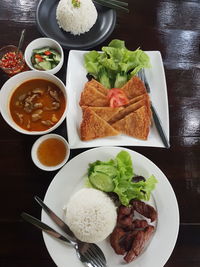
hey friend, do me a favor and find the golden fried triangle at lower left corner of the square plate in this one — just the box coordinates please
[80,108,119,141]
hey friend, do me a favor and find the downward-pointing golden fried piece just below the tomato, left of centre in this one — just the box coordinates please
[82,106,123,121]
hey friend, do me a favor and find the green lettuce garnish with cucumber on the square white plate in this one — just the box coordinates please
[84,39,150,89]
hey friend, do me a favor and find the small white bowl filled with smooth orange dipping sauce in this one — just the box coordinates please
[31,134,70,171]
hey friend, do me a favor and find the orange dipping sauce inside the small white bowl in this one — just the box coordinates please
[37,138,67,166]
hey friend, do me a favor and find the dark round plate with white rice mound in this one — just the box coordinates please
[36,0,117,50]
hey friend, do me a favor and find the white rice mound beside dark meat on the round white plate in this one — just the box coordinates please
[65,188,117,243]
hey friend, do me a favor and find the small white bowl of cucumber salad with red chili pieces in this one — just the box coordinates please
[24,38,64,74]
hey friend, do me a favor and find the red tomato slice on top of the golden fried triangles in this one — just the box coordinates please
[108,88,129,108]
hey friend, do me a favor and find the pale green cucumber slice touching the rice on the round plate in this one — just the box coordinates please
[89,172,115,192]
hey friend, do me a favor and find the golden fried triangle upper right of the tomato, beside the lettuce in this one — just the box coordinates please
[120,76,146,99]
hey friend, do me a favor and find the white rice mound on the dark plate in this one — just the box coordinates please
[56,0,97,35]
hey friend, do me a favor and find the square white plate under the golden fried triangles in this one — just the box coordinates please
[66,50,169,149]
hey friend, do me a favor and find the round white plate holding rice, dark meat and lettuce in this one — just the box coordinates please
[42,147,179,267]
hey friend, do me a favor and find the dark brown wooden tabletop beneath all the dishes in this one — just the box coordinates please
[0,0,200,267]
